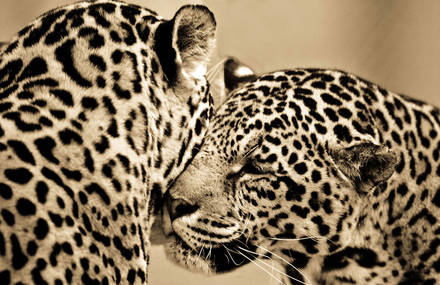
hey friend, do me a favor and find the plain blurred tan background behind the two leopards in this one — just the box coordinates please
[0,0,440,285]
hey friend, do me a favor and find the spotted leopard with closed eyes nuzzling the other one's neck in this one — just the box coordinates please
[162,68,440,285]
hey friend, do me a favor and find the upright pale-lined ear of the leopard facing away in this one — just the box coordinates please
[154,5,216,86]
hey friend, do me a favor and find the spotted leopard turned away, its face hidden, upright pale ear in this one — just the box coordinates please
[0,0,216,285]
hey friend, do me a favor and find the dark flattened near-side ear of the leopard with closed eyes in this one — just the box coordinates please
[329,143,397,193]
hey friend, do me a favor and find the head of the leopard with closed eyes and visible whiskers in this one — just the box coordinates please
[164,68,396,273]
